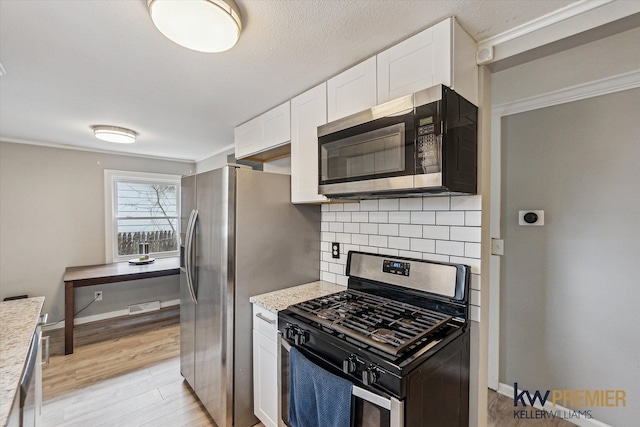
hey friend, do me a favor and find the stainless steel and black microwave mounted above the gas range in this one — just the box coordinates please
[318,85,478,199]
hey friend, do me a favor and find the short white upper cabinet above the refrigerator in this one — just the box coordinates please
[234,101,291,161]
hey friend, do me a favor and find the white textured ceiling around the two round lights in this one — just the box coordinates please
[0,0,574,161]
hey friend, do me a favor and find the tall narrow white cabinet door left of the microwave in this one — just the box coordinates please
[291,83,328,203]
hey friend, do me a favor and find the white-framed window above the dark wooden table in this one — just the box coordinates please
[105,170,180,262]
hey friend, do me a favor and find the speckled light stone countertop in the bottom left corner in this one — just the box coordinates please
[0,297,44,425]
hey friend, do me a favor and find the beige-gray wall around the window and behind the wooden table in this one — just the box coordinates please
[0,142,195,322]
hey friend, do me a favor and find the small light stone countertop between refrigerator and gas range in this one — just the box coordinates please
[249,280,347,313]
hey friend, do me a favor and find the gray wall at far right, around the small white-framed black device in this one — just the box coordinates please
[494,77,640,426]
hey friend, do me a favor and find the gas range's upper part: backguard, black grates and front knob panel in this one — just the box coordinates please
[278,252,470,408]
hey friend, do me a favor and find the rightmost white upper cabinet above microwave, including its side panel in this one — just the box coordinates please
[377,18,478,105]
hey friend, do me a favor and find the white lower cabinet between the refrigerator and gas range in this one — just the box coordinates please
[253,304,278,427]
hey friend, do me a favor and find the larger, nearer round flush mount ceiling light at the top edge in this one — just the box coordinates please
[147,0,242,52]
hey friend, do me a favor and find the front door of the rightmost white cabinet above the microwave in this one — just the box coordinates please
[377,18,452,104]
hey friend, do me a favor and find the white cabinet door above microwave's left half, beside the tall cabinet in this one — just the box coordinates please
[327,56,378,122]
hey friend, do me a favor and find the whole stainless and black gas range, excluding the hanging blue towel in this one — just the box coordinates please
[278,252,470,427]
